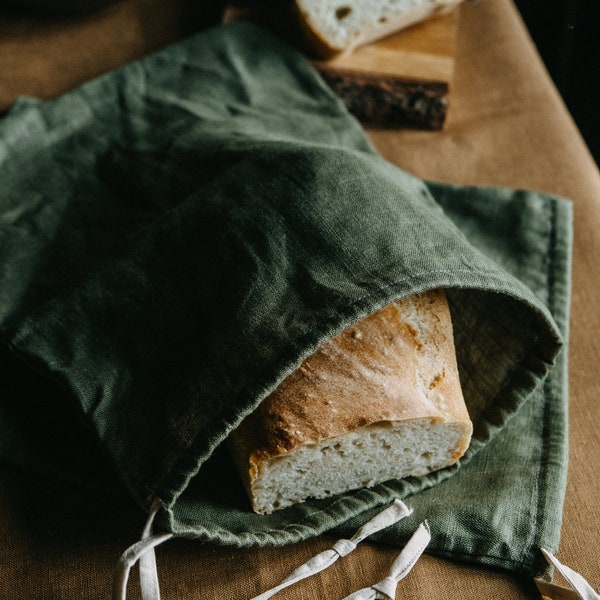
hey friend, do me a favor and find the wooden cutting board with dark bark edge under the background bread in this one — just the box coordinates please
[225,2,459,129]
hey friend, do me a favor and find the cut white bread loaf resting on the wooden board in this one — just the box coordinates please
[295,0,462,58]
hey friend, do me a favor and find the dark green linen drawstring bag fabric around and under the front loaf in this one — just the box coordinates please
[0,24,571,573]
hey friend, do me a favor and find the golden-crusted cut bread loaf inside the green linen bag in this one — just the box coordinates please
[230,290,472,513]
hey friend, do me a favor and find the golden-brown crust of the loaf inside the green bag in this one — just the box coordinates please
[230,290,472,510]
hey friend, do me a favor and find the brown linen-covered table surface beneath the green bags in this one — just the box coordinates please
[0,0,600,600]
